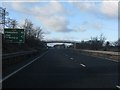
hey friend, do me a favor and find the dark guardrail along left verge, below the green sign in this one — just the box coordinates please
[2,51,38,69]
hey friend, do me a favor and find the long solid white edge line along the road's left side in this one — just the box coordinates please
[0,51,48,83]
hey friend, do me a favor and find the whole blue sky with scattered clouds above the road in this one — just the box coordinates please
[0,0,118,41]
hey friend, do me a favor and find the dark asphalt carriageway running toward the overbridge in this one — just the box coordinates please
[2,49,120,89]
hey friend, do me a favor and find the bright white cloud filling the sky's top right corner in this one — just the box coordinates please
[70,0,118,19]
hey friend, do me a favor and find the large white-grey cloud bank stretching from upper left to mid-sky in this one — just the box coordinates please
[3,2,72,32]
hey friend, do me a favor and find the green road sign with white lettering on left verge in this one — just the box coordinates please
[4,29,25,43]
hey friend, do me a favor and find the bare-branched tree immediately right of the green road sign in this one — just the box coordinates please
[20,19,45,47]
